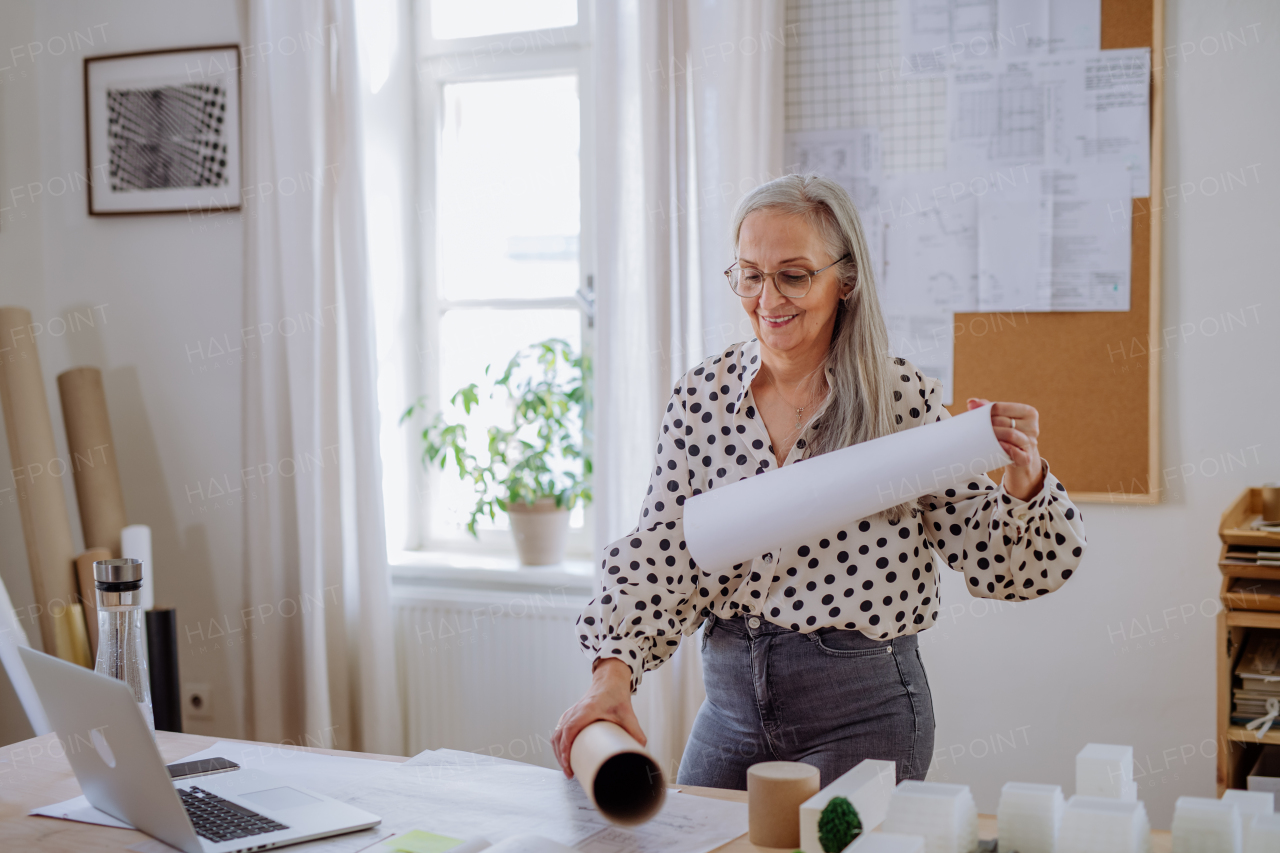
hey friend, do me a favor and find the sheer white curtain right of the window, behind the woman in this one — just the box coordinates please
[594,0,791,770]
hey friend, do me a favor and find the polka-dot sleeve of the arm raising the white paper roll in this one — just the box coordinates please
[923,379,1087,601]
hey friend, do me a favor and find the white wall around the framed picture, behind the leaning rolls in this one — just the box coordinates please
[0,0,243,742]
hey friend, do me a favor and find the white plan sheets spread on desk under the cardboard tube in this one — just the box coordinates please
[340,751,746,853]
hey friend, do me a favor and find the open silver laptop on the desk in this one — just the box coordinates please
[18,648,381,853]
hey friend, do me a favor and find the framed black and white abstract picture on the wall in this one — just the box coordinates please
[84,45,242,216]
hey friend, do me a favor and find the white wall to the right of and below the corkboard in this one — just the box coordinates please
[922,0,1280,827]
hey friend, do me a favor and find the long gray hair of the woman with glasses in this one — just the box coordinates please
[733,173,906,517]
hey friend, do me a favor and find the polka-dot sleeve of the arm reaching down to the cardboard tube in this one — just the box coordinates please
[577,386,703,692]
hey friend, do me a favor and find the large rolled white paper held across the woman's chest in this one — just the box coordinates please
[685,403,1011,567]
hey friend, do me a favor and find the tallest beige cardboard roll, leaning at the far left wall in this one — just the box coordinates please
[0,306,87,661]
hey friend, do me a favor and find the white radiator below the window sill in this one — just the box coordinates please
[393,584,591,767]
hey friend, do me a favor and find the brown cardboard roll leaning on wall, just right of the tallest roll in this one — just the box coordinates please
[58,368,125,557]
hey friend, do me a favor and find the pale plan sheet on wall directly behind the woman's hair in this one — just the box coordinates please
[786,127,884,279]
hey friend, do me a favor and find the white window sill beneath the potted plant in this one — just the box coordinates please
[389,551,595,596]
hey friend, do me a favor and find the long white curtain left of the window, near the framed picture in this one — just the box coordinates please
[241,0,402,753]
